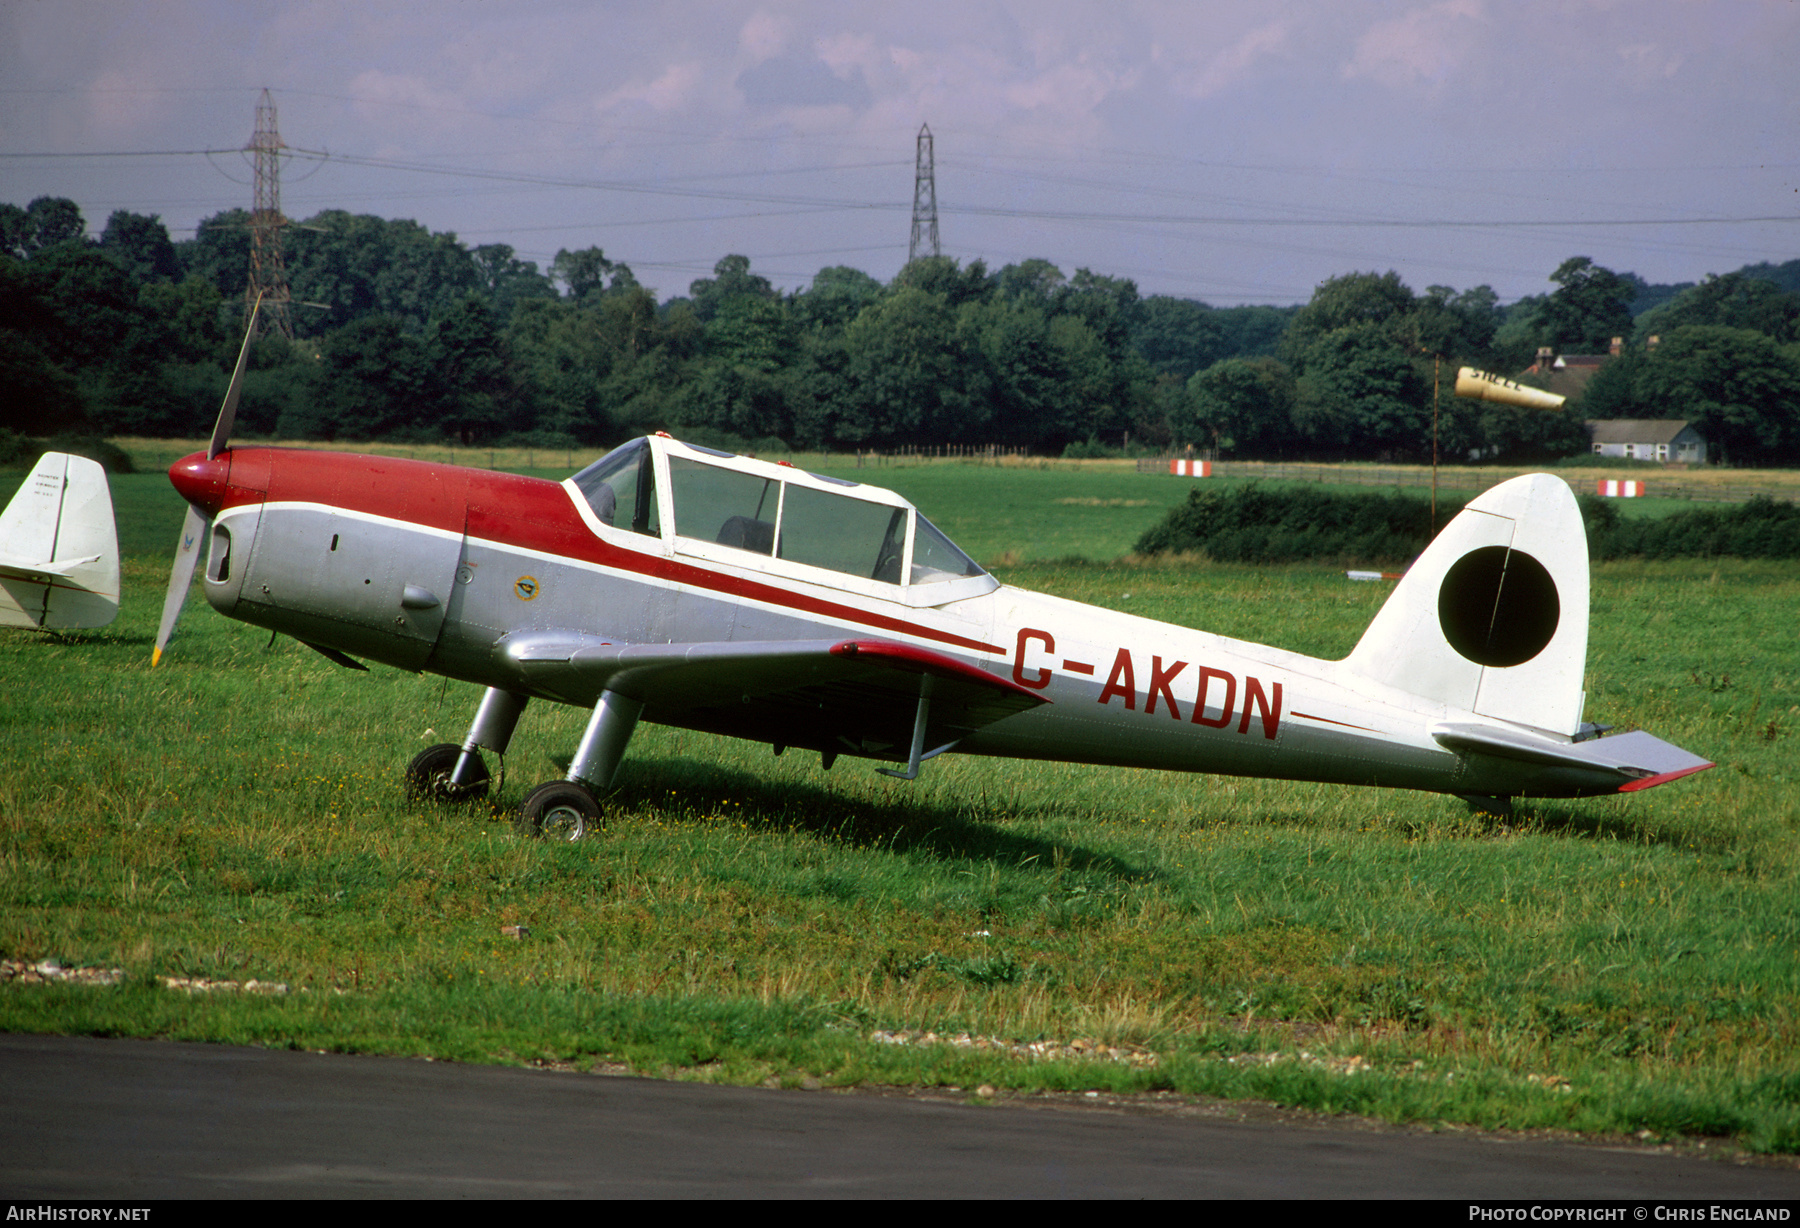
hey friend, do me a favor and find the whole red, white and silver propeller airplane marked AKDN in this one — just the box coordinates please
[157,329,1712,839]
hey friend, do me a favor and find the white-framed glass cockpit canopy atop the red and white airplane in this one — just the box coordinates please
[569,438,999,605]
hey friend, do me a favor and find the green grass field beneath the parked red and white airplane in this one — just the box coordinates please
[10,446,1800,1152]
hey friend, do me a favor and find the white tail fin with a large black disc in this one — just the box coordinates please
[1345,474,1588,736]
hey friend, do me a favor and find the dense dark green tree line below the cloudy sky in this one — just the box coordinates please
[0,198,1800,461]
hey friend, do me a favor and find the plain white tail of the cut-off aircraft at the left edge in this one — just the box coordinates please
[0,452,119,628]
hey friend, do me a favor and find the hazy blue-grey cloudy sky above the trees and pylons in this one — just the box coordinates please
[0,0,1800,304]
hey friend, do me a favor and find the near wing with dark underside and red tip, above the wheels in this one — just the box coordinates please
[500,632,1048,762]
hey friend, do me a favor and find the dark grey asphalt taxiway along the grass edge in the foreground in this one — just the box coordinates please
[0,1035,1800,1201]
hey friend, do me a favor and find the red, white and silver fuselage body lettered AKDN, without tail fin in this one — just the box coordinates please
[171,445,1648,796]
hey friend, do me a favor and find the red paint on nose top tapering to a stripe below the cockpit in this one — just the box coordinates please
[207,448,1004,654]
